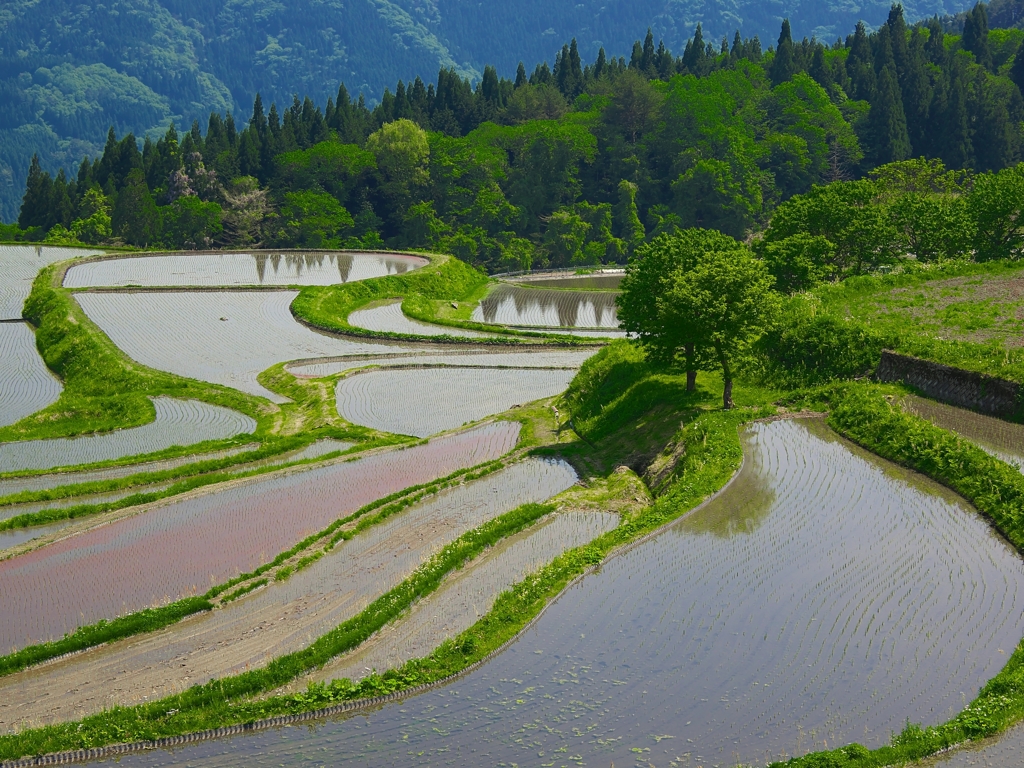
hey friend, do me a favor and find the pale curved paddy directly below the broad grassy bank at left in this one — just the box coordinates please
[0,397,256,472]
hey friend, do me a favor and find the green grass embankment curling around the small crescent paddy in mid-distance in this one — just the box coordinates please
[292,255,593,346]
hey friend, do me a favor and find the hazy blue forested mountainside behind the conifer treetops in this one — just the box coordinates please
[0,0,967,221]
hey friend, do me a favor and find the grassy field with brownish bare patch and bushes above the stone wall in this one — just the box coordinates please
[759,262,1024,386]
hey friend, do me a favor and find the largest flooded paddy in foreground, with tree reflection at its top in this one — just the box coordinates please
[97,421,1024,766]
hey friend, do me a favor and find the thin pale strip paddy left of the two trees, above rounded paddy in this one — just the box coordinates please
[288,348,598,379]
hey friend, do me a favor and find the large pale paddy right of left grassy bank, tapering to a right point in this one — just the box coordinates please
[76,291,416,402]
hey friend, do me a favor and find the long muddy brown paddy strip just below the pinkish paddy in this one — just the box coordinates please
[0,459,577,730]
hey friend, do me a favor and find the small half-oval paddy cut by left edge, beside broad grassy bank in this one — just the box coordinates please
[0,323,63,427]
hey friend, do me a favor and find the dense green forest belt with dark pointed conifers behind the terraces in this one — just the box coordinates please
[6,4,1024,276]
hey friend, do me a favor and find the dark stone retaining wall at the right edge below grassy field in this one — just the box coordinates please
[874,350,1021,419]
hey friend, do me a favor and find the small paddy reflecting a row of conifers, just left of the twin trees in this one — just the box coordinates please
[472,284,618,329]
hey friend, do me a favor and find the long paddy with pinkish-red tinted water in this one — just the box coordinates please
[0,422,519,649]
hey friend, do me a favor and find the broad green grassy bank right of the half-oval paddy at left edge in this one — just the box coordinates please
[0,264,275,441]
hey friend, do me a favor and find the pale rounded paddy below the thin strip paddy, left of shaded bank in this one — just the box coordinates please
[337,368,575,437]
